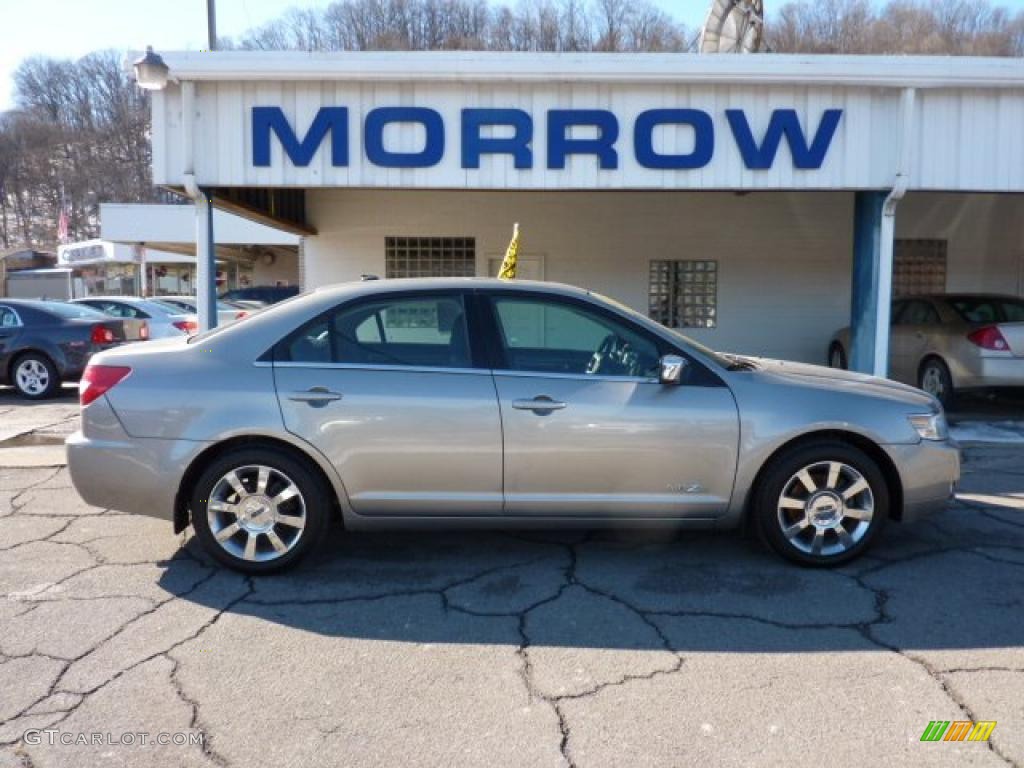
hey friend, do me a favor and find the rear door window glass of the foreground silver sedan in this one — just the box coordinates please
[275,295,472,368]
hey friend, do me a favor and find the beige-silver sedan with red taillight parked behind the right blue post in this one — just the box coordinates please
[828,294,1024,406]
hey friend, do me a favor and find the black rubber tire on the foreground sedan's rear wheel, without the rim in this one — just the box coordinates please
[190,447,334,574]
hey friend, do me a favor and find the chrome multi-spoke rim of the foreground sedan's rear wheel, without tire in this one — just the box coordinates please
[206,465,306,562]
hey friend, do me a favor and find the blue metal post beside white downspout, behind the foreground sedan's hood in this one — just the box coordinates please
[849,191,886,374]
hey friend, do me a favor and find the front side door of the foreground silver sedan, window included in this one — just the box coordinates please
[486,292,739,518]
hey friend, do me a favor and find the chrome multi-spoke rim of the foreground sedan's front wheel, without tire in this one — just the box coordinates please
[778,461,874,557]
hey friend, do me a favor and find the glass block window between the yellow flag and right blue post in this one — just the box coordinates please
[648,259,718,328]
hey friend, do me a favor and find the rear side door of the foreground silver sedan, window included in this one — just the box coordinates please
[273,291,502,516]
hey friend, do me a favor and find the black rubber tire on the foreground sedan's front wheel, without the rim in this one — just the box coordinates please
[752,440,890,567]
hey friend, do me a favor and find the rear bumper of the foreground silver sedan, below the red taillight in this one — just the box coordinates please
[67,397,207,520]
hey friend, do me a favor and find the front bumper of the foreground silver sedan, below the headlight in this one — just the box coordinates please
[883,440,961,522]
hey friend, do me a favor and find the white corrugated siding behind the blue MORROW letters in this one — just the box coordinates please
[153,80,1024,191]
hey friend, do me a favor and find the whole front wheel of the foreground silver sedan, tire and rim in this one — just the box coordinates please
[754,440,889,566]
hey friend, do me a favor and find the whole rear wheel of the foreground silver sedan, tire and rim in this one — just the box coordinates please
[191,449,332,573]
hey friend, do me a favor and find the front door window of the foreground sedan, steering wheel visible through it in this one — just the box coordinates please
[493,296,659,377]
